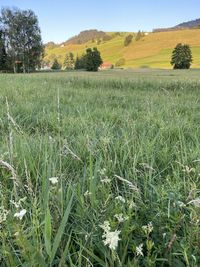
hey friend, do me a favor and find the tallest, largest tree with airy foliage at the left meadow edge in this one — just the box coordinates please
[0,8,43,73]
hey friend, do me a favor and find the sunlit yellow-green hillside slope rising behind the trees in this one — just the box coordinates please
[45,29,200,68]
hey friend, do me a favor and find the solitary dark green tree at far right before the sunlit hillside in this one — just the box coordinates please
[171,44,192,69]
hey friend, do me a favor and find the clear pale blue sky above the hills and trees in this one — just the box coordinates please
[0,0,200,43]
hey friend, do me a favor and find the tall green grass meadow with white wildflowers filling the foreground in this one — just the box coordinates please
[0,71,200,267]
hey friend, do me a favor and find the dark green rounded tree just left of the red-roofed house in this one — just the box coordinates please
[84,47,103,71]
